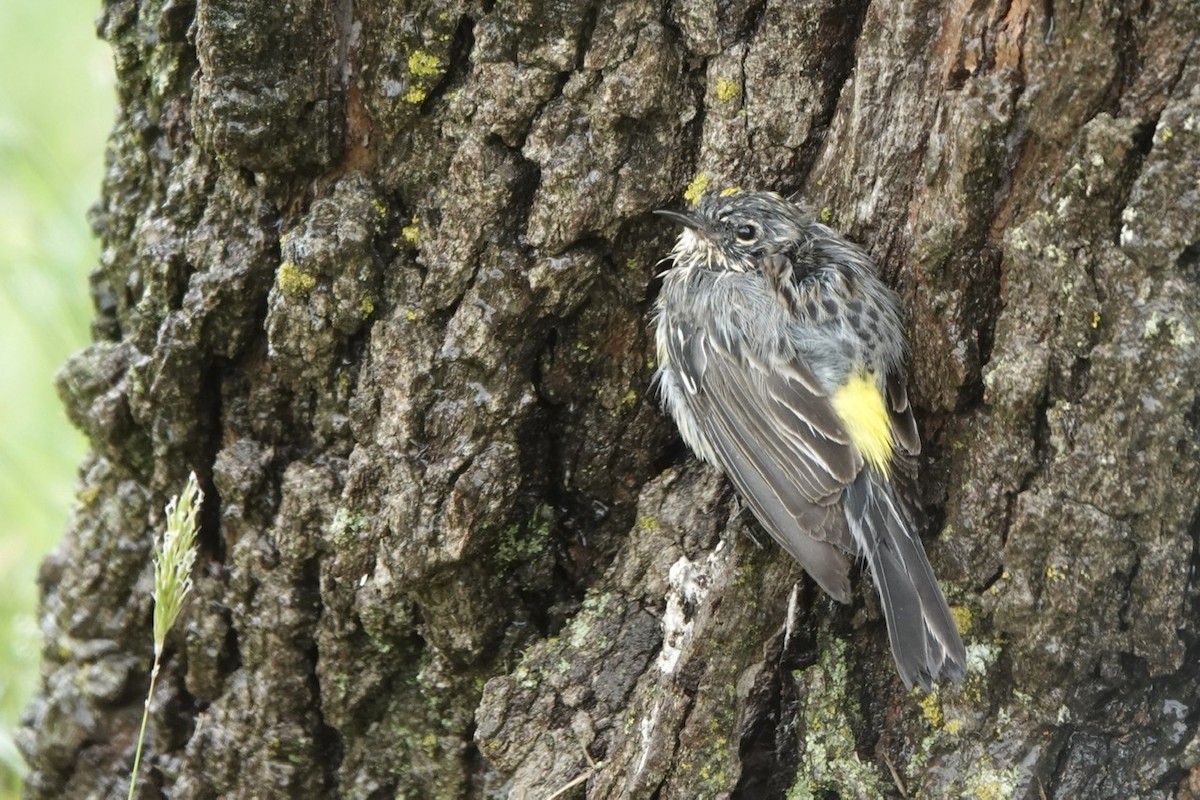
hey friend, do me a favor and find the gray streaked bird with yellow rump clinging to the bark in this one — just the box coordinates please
[655,192,966,691]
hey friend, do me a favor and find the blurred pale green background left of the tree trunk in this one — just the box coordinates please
[0,0,115,800]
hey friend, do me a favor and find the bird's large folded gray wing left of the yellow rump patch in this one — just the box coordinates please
[667,324,863,602]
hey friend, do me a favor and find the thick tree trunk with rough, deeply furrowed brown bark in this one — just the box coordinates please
[22,0,1200,799]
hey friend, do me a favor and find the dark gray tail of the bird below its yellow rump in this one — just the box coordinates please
[845,467,966,692]
